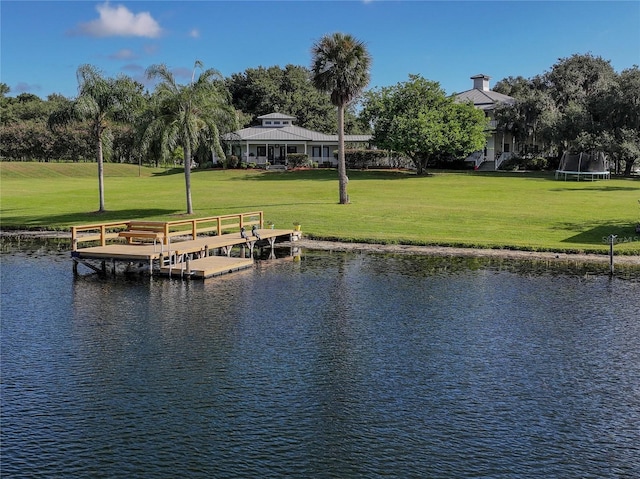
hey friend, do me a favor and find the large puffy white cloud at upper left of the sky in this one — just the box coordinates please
[78,2,162,38]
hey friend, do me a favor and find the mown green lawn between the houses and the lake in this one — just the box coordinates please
[0,163,640,254]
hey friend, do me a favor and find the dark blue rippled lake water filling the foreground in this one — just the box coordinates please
[0,246,640,478]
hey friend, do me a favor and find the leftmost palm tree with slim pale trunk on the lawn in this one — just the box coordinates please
[48,65,140,213]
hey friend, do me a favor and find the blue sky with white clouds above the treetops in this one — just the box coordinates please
[0,0,640,98]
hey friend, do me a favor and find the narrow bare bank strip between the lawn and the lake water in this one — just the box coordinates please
[5,230,640,267]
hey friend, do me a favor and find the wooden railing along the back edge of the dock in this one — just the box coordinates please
[71,211,264,251]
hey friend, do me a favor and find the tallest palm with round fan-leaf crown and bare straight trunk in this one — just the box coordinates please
[311,33,371,204]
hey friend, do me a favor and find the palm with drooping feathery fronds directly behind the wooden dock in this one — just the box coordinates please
[143,61,237,215]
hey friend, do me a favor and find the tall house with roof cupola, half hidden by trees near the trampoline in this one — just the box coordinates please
[455,73,516,170]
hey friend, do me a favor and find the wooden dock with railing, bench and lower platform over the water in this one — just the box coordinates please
[71,211,300,278]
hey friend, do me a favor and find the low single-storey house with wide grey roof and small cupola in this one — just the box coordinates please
[225,113,371,166]
